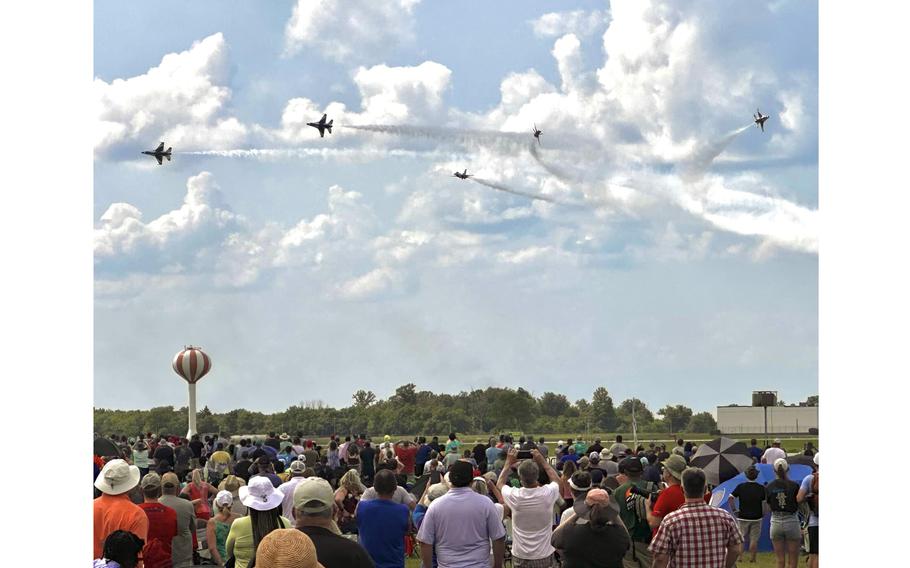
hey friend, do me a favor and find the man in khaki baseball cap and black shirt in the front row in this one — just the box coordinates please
[294,477,374,568]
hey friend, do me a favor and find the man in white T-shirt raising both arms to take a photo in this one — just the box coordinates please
[496,449,562,568]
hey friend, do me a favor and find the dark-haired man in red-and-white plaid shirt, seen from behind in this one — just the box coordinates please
[650,467,743,568]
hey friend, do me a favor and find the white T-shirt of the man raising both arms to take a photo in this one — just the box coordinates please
[502,481,559,560]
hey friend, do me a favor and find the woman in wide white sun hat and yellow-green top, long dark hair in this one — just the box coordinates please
[225,475,294,568]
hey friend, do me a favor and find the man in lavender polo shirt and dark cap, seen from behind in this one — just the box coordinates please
[417,462,510,568]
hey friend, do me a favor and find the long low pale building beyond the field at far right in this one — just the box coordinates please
[717,406,818,434]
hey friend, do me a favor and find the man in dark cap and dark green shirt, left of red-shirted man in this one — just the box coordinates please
[604,457,656,568]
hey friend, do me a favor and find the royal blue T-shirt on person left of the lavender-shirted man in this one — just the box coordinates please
[357,499,410,568]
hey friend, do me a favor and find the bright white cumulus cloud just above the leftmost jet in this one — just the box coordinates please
[93,33,247,156]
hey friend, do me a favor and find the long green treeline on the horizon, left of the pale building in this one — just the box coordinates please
[94,383,717,436]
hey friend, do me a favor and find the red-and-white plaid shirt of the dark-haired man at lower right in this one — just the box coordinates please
[649,503,743,568]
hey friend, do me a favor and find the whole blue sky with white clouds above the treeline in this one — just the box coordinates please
[94,0,818,418]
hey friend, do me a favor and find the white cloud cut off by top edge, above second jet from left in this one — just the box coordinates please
[284,0,420,61]
